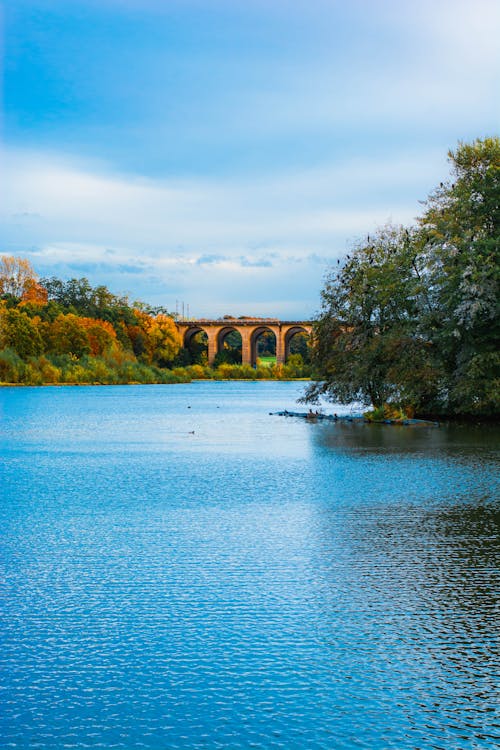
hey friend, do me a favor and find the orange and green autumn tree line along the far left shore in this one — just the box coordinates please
[0,264,309,385]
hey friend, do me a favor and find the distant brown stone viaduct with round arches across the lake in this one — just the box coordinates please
[177,318,312,366]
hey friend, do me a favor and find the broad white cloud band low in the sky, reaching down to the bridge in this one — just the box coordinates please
[0,144,450,317]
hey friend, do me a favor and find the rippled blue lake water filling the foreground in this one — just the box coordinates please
[0,382,500,750]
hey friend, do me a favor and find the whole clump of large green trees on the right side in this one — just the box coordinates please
[307,137,500,416]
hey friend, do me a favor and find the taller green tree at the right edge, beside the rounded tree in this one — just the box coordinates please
[419,138,500,414]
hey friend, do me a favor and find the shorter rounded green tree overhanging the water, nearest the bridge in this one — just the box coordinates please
[308,225,436,406]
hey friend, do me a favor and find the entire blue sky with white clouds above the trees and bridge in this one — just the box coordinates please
[0,0,500,320]
